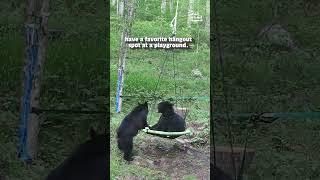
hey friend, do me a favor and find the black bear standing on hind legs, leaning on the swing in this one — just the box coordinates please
[117,102,149,161]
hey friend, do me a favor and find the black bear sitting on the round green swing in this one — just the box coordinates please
[150,101,186,132]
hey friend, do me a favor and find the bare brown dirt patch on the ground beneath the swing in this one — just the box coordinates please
[130,121,210,180]
